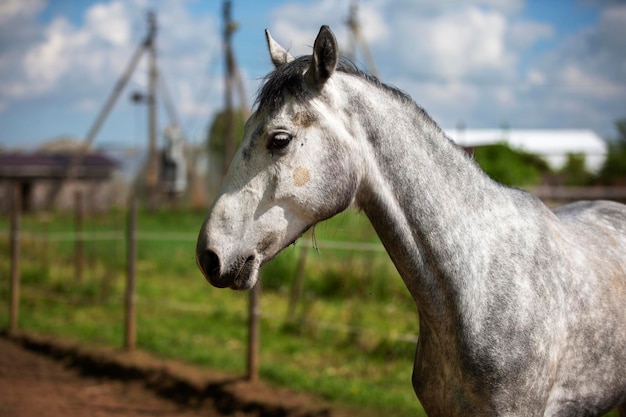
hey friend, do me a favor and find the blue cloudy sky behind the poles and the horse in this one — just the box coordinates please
[0,0,626,153]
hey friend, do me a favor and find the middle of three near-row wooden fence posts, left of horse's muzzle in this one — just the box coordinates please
[124,191,137,350]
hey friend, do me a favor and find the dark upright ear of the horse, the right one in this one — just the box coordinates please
[307,25,339,90]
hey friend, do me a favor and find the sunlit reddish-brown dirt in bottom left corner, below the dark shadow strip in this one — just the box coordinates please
[0,337,221,417]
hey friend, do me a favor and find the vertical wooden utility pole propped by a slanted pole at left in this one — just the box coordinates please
[145,12,159,209]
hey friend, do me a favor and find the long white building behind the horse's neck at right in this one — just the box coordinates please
[444,128,607,173]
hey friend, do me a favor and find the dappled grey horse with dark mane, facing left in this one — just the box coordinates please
[196,26,626,417]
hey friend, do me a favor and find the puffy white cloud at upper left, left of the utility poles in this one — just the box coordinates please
[0,2,132,102]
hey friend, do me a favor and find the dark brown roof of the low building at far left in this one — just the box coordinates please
[0,153,117,179]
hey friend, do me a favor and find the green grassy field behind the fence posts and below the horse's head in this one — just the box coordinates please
[0,211,423,416]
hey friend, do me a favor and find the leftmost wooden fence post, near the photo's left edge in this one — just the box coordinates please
[9,182,22,332]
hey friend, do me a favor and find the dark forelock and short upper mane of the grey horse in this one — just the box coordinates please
[255,55,413,115]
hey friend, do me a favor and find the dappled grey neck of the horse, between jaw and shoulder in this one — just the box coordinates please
[348,80,506,324]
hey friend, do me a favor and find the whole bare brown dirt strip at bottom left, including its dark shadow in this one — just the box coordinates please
[0,332,342,417]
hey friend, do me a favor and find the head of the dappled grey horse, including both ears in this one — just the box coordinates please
[196,26,358,290]
